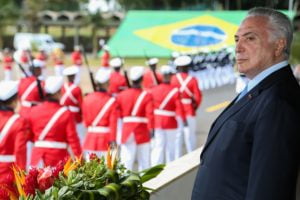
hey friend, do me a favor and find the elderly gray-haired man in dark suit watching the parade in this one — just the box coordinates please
[192,8,300,200]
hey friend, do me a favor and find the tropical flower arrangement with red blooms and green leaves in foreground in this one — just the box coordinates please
[0,146,164,200]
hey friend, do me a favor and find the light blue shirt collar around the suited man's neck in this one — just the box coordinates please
[247,60,288,92]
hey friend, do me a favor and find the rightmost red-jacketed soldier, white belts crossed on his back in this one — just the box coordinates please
[171,56,202,158]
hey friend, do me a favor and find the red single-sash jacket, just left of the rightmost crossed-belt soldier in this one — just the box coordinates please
[151,83,185,129]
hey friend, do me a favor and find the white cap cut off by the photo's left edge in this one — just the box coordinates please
[0,81,18,101]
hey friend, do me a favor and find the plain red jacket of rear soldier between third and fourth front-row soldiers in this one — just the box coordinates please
[108,71,128,94]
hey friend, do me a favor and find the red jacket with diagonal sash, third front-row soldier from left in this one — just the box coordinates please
[82,92,118,151]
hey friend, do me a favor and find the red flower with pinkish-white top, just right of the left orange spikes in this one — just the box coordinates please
[37,166,54,192]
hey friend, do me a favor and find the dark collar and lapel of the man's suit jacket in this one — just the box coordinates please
[201,65,291,155]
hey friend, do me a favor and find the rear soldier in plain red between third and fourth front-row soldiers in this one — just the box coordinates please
[108,58,128,96]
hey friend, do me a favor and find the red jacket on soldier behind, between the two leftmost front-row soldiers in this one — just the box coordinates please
[18,76,44,118]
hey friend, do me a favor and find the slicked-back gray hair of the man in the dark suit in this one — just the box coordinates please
[247,7,293,58]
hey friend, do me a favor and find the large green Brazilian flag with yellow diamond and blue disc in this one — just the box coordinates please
[108,11,293,57]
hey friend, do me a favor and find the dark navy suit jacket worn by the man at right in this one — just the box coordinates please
[192,66,300,200]
